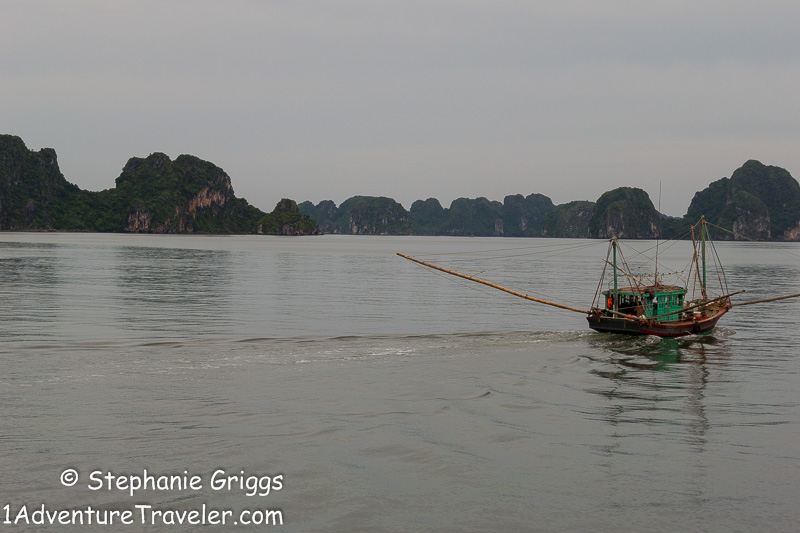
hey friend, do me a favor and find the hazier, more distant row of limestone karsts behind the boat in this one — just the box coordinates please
[299,160,800,241]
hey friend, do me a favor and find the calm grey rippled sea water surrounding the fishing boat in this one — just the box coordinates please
[0,233,800,532]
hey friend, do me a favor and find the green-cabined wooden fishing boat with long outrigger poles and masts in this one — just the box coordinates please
[397,217,800,337]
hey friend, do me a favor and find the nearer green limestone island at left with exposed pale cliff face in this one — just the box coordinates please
[0,135,319,234]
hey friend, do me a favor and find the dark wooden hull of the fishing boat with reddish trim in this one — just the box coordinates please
[586,307,729,337]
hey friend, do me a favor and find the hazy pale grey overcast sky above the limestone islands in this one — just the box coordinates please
[0,0,800,216]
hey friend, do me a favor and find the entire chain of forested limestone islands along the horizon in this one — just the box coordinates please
[0,135,800,241]
